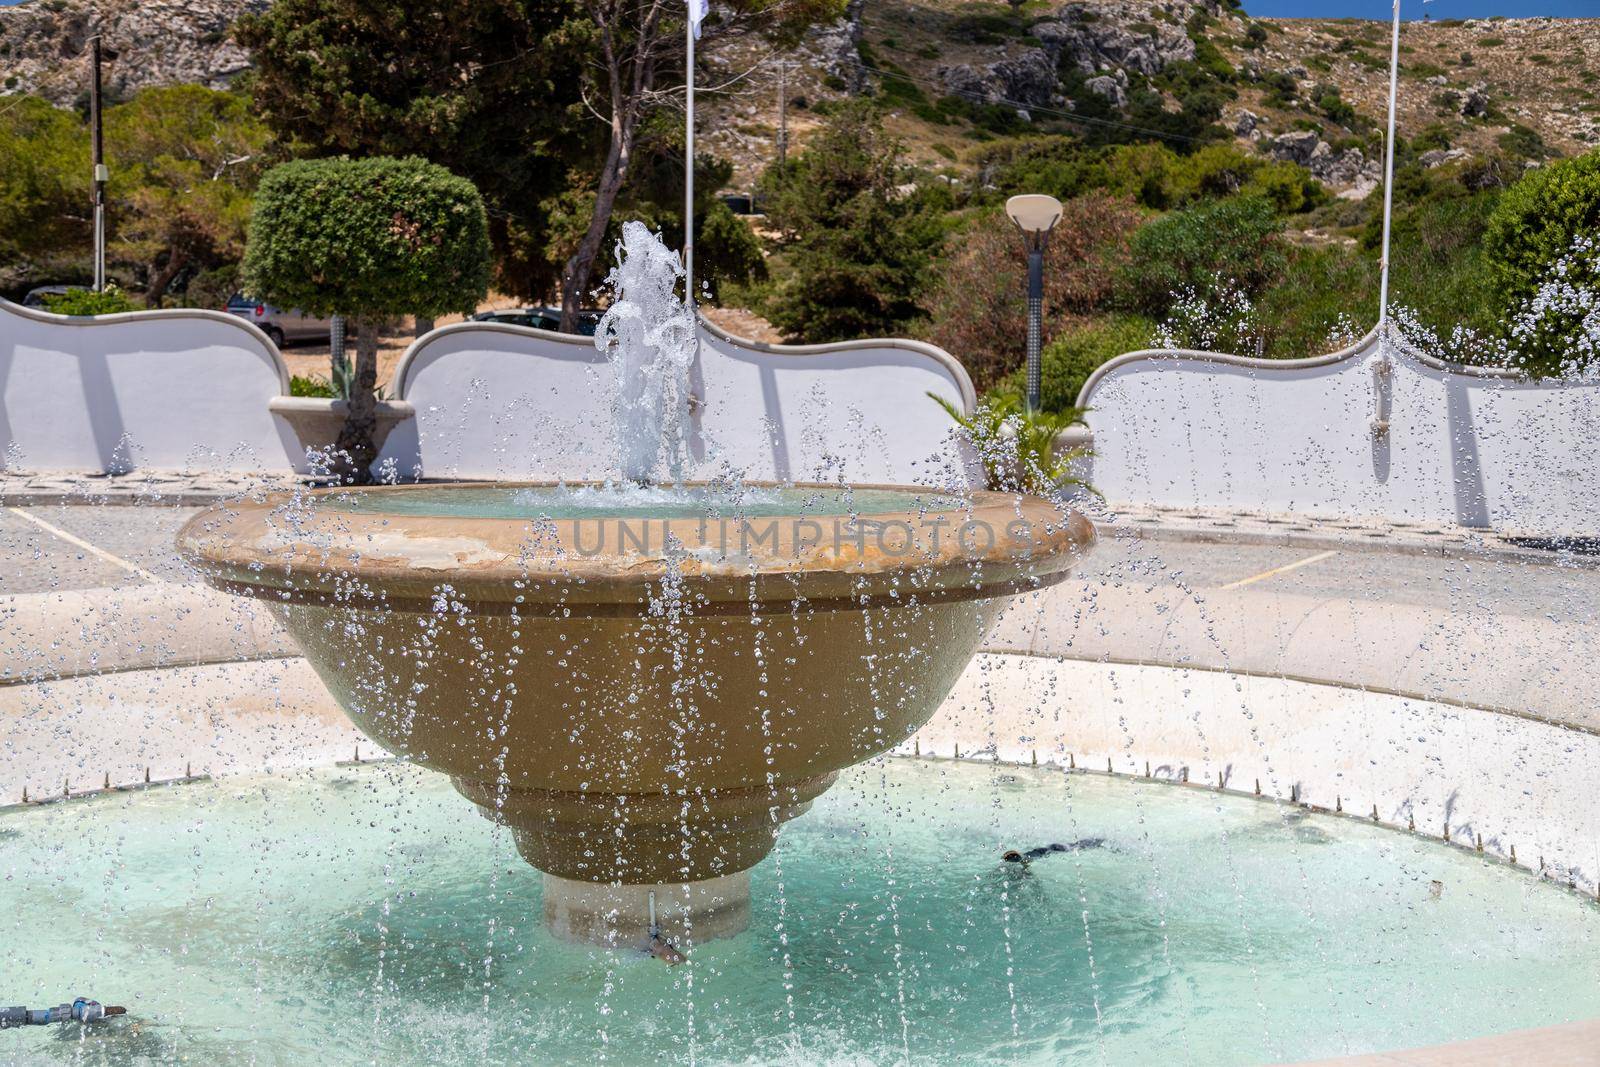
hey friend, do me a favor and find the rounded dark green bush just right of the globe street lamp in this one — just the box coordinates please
[1118,197,1285,318]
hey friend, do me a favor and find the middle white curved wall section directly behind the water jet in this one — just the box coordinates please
[379,316,974,482]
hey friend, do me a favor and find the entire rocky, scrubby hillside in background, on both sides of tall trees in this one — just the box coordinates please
[0,0,1600,198]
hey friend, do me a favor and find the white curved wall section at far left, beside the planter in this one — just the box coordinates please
[0,299,299,472]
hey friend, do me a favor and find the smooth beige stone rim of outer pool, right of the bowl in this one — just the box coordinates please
[986,579,1600,733]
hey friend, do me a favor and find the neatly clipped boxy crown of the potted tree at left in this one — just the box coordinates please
[243,157,490,318]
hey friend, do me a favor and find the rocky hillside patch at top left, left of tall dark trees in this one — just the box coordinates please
[0,0,270,104]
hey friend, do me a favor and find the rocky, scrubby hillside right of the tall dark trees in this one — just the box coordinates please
[702,0,1600,197]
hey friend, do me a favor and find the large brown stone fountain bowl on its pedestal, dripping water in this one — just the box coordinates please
[179,485,1094,941]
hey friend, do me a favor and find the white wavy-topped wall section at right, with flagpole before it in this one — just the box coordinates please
[1078,334,1600,534]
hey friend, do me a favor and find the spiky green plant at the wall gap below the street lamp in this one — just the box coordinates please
[928,394,1093,496]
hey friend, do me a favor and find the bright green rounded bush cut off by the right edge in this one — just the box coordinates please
[1483,149,1600,299]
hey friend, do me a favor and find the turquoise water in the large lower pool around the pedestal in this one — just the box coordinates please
[0,760,1600,1067]
